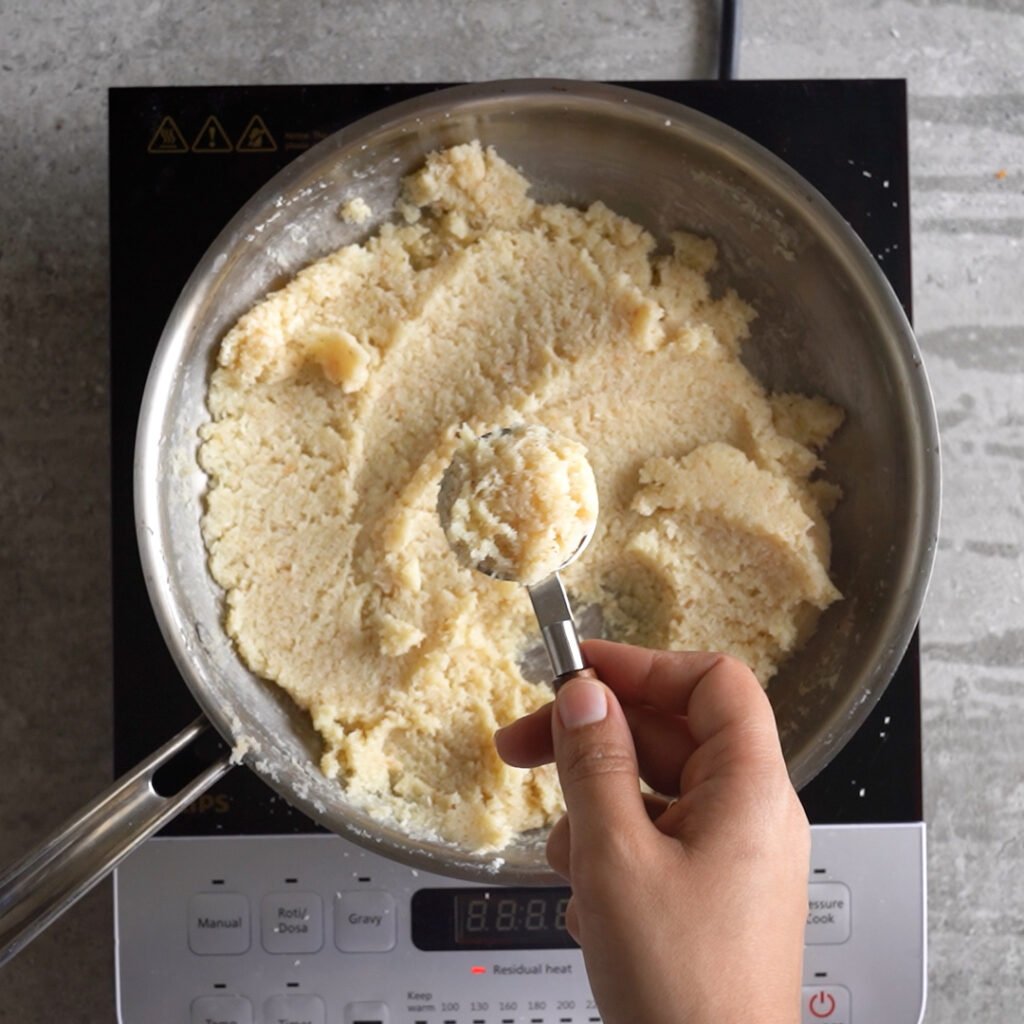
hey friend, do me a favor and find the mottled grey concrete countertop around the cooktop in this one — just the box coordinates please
[0,0,1024,1024]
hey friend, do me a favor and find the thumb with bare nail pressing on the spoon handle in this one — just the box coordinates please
[551,674,650,852]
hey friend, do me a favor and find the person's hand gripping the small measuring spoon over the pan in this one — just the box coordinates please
[495,640,810,1024]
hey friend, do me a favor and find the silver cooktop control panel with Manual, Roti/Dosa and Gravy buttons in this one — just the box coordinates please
[115,823,925,1024]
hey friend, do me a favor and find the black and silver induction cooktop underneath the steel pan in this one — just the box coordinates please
[110,81,925,1024]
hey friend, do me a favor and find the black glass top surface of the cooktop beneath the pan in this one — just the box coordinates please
[110,81,922,836]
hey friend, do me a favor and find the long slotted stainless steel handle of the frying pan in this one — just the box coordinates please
[0,717,231,967]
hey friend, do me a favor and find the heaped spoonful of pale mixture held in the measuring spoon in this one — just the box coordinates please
[437,426,597,585]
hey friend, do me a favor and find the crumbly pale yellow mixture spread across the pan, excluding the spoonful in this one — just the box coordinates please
[200,144,842,850]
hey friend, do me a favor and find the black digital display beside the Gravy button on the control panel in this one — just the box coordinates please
[412,887,577,950]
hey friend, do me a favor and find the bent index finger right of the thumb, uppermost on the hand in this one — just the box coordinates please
[583,640,777,744]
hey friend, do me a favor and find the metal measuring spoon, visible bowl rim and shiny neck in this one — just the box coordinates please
[437,427,594,689]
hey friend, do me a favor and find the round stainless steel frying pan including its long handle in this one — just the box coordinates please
[0,81,939,958]
